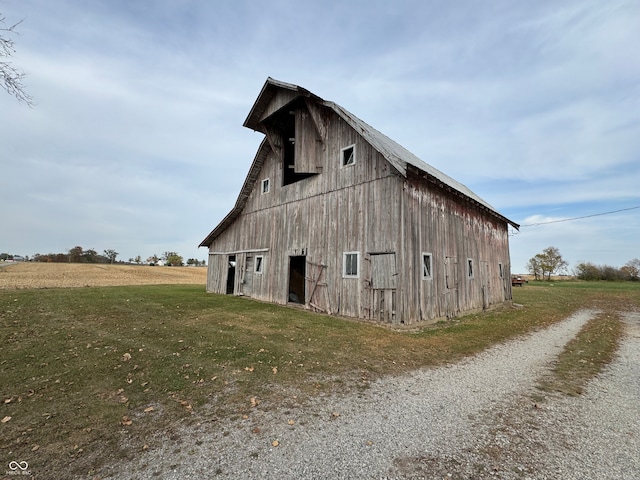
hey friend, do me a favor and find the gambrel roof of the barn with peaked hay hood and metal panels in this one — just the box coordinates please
[200,77,519,247]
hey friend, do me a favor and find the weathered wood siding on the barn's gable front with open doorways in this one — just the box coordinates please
[207,107,402,318]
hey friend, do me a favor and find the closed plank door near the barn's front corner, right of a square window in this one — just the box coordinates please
[370,253,398,323]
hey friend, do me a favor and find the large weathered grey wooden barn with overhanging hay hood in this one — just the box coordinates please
[200,78,518,324]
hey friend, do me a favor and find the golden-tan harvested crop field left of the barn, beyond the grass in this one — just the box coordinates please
[0,263,207,290]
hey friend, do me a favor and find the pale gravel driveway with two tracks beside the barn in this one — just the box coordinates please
[100,311,640,479]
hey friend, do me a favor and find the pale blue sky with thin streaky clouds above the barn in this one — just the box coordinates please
[0,0,640,272]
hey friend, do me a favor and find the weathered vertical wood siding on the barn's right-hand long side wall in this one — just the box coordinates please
[400,172,511,321]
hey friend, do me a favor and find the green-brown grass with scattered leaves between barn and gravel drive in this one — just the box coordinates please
[0,272,640,478]
